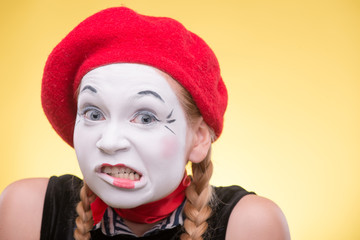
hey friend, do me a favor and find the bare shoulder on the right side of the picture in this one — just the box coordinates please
[226,195,290,240]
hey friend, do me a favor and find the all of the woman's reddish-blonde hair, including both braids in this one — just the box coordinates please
[74,80,215,240]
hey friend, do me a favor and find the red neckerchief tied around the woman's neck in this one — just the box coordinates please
[91,173,191,225]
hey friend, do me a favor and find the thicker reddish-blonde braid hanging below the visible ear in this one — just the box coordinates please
[181,151,213,240]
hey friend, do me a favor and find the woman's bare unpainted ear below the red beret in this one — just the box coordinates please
[189,118,211,163]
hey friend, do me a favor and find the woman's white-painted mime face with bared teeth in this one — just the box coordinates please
[74,63,191,208]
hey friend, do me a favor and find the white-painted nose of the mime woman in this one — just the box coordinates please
[96,126,130,155]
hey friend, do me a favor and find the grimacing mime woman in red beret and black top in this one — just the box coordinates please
[0,7,290,240]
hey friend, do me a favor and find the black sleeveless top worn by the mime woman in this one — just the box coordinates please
[40,175,254,240]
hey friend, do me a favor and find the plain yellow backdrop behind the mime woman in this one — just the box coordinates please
[0,0,360,240]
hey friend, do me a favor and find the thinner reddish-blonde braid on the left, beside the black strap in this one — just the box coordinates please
[74,182,95,240]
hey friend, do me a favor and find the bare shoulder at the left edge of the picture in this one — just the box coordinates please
[0,178,49,240]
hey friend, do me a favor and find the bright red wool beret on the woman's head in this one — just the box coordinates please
[41,7,227,146]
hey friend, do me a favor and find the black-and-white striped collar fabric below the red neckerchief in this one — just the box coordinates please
[93,201,185,237]
